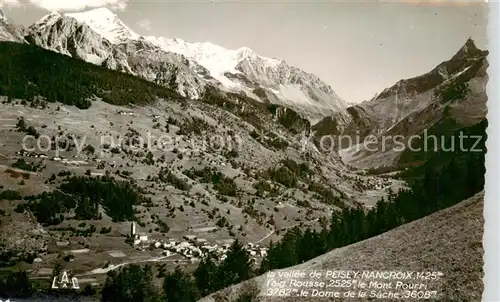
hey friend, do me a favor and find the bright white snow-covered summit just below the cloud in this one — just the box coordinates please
[64,7,140,44]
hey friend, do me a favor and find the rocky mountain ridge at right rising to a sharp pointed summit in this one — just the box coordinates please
[312,38,488,168]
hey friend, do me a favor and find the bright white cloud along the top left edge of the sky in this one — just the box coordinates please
[0,0,129,11]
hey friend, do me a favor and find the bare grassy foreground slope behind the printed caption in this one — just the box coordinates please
[200,192,484,302]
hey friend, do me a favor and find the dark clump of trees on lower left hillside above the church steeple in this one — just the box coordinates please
[16,176,150,225]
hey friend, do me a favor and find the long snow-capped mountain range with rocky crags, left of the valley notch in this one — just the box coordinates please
[0,8,347,121]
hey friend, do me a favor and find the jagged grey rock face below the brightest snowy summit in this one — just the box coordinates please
[26,12,209,98]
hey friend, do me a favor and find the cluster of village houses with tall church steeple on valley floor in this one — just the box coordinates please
[131,223,267,262]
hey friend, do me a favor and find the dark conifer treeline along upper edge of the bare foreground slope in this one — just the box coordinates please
[259,120,487,273]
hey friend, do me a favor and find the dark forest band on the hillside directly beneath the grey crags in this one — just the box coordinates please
[0,42,182,109]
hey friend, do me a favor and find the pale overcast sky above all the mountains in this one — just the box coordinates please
[0,0,488,102]
